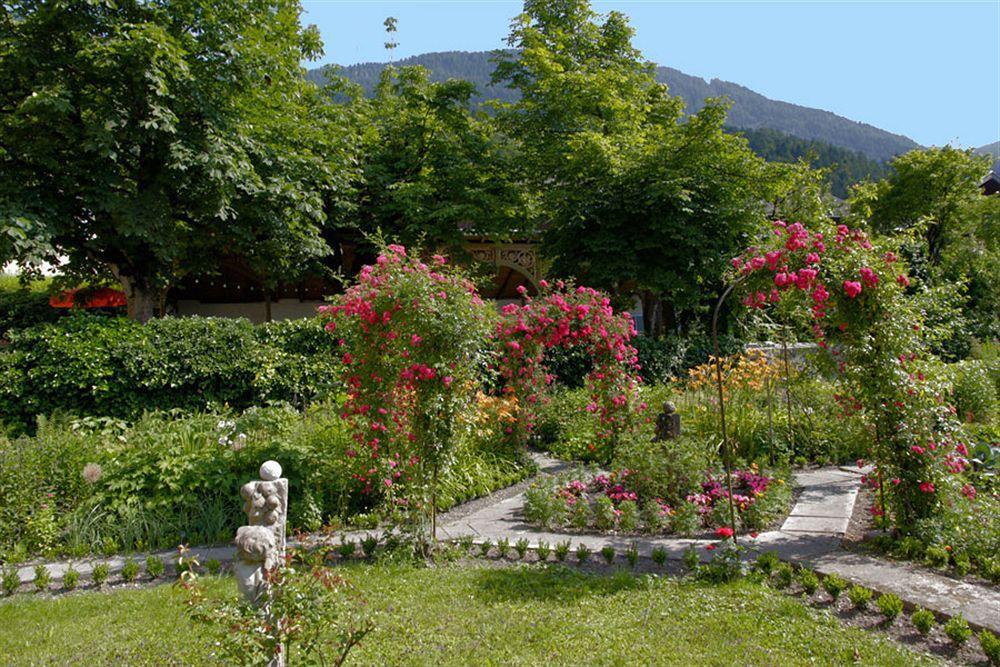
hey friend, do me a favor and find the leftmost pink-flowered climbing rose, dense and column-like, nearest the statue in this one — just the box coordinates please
[321,245,496,540]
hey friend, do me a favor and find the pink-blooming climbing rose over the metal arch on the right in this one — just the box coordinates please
[732,221,968,532]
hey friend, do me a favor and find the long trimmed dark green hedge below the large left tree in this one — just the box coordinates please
[0,315,339,427]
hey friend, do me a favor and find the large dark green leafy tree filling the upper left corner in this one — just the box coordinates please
[0,0,348,320]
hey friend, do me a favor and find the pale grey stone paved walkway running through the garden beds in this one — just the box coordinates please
[9,454,1000,634]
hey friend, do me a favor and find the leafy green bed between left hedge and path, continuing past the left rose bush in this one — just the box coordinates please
[0,404,531,558]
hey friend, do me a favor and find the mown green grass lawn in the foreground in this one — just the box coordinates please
[0,565,934,666]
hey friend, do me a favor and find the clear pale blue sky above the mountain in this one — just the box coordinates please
[303,0,1000,146]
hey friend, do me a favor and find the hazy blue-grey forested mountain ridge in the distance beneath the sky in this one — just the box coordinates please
[309,51,918,161]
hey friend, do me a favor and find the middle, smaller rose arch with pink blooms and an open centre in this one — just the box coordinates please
[496,281,642,462]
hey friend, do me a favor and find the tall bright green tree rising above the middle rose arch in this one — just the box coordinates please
[495,0,769,333]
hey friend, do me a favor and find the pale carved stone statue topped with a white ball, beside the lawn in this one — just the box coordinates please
[233,461,288,604]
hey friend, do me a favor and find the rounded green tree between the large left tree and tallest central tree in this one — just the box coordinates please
[352,61,524,254]
